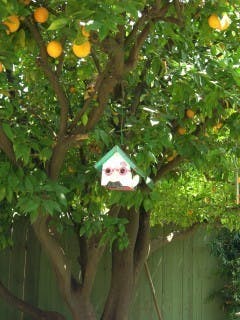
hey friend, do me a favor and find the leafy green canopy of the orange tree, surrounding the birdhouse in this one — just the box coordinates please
[0,0,240,248]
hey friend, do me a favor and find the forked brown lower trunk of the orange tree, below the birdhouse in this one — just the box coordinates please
[31,204,149,320]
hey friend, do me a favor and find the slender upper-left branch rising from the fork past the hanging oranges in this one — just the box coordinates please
[25,18,69,137]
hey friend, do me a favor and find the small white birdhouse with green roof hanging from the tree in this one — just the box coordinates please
[95,146,144,190]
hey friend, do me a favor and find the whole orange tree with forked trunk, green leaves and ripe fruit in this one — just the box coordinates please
[0,0,240,320]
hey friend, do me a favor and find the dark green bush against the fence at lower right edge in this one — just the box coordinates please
[211,228,240,320]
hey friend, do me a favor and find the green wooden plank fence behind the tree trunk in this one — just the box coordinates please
[0,223,227,320]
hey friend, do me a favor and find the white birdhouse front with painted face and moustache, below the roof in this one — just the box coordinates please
[101,152,139,190]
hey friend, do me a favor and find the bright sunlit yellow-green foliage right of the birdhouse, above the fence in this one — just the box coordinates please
[149,164,239,229]
